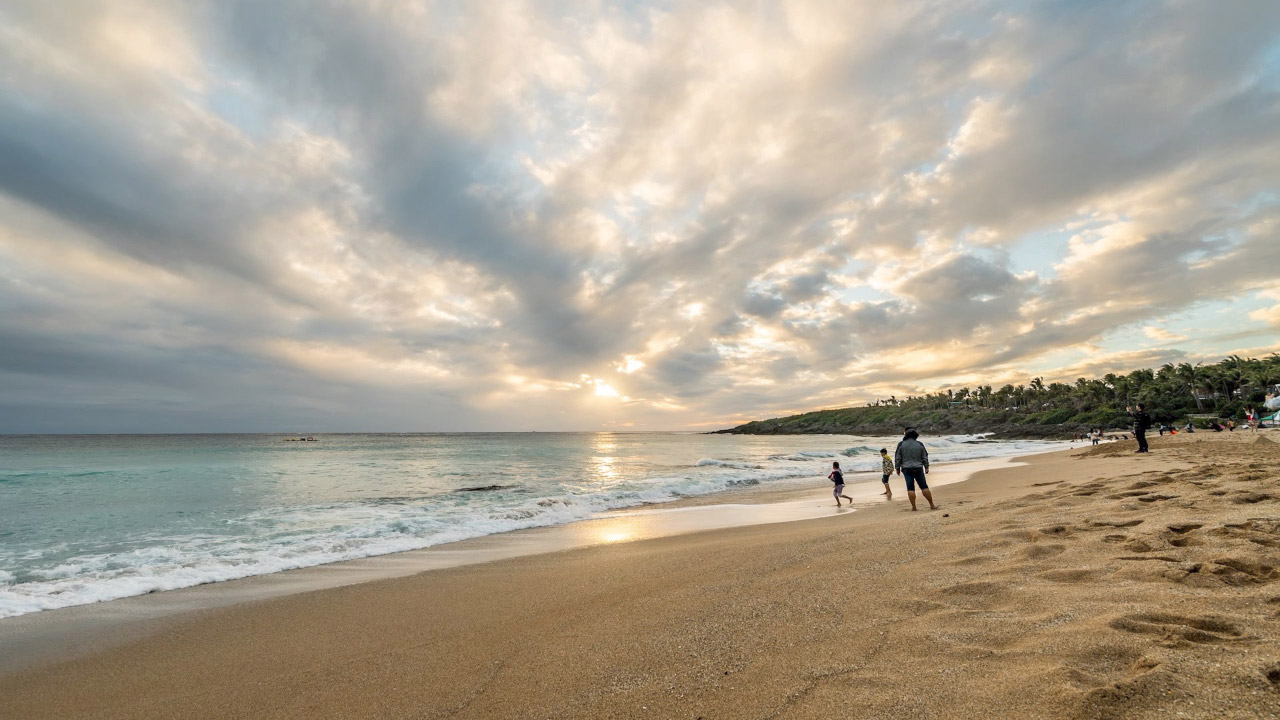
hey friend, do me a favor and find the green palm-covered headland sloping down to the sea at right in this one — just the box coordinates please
[718,352,1280,438]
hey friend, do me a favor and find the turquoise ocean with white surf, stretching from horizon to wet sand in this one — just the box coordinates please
[0,433,1061,618]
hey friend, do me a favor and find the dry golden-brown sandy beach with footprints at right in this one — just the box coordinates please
[0,432,1280,719]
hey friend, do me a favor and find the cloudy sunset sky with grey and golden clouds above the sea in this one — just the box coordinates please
[0,0,1280,433]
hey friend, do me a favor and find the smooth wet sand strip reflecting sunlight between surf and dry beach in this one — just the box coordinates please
[0,451,1029,675]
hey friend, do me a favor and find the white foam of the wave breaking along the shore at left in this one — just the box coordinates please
[0,462,819,618]
